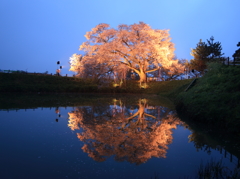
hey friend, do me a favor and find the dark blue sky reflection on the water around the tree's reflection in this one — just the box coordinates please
[0,107,234,179]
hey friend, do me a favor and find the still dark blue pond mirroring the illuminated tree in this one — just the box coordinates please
[0,96,239,179]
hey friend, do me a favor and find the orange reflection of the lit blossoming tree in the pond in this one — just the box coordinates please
[68,99,180,164]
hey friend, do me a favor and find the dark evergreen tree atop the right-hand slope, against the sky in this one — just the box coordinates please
[190,36,223,72]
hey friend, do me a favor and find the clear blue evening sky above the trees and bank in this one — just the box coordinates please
[0,0,240,74]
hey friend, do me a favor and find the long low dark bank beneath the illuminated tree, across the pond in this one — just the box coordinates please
[0,73,189,95]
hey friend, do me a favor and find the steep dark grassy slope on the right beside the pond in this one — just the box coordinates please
[176,64,240,138]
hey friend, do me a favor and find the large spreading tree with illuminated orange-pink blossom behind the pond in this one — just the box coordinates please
[70,22,181,82]
